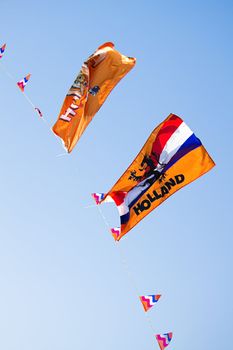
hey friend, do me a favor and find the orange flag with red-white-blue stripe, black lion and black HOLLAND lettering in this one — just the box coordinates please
[93,114,215,241]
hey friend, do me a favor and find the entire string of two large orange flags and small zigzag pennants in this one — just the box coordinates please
[0,42,215,350]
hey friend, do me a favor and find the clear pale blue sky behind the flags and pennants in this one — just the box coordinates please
[0,0,233,350]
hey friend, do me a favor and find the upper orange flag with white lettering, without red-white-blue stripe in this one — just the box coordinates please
[52,42,136,153]
